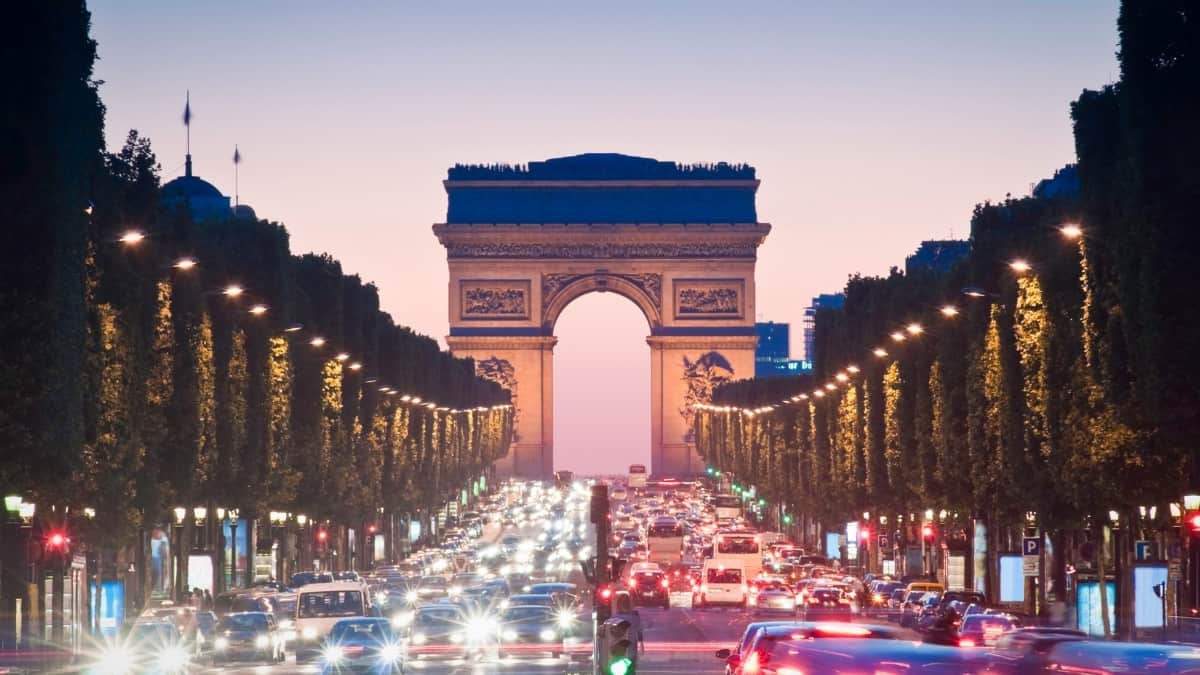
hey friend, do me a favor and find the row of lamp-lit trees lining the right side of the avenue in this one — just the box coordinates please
[695,2,1200,628]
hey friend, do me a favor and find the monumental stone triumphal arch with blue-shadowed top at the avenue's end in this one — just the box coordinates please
[433,154,770,478]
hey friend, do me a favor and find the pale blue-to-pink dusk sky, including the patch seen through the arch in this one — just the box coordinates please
[91,0,1117,471]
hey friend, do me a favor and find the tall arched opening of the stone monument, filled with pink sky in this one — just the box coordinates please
[551,288,652,476]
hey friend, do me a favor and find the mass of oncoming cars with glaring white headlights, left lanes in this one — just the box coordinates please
[82,477,593,675]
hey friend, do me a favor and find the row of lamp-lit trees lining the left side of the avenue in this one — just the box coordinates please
[0,2,512,610]
